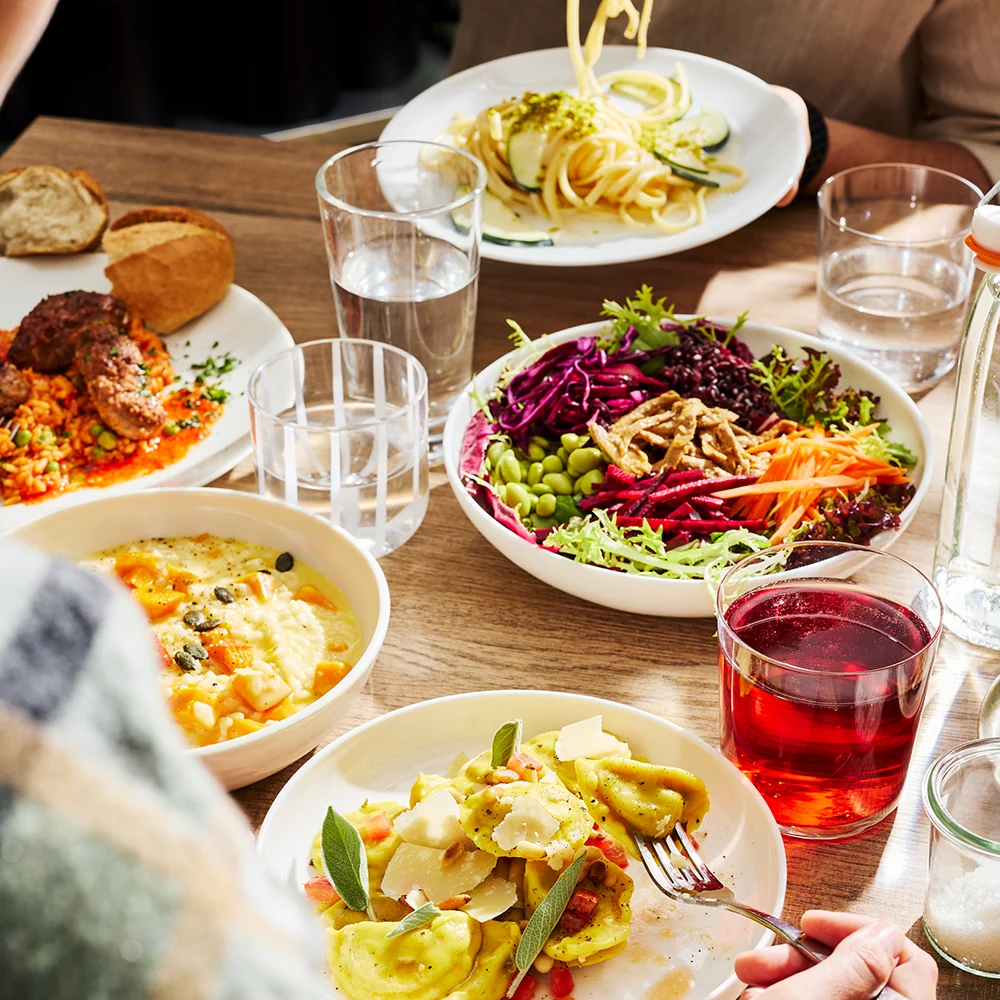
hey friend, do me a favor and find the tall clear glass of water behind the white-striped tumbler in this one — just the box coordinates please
[316,140,486,461]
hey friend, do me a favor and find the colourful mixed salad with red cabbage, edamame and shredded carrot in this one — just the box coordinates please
[461,285,917,579]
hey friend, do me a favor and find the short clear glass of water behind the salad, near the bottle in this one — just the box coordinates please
[817,163,982,392]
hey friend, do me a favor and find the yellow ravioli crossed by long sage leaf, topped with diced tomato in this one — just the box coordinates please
[524,861,633,965]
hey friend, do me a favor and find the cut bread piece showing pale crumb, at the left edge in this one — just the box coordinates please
[0,166,108,257]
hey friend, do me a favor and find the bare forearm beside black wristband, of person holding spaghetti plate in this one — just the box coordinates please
[806,118,992,192]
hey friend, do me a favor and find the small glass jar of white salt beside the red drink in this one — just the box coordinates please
[924,739,1000,979]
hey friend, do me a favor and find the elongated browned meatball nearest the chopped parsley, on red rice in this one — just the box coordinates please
[76,323,167,441]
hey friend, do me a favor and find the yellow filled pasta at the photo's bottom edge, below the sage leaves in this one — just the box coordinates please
[330,910,521,1000]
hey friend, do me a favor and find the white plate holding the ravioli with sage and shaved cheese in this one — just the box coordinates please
[257,691,786,1000]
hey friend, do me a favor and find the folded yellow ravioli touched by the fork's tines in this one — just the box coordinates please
[576,757,708,843]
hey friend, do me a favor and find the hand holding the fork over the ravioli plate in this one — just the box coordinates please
[736,910,937,1000]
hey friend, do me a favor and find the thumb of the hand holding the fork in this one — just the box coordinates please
[736,923,906,1000]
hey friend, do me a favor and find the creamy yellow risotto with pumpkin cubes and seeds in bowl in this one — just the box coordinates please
[84,535,364,746]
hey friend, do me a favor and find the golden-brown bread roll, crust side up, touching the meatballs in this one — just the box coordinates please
[104,205,236,333]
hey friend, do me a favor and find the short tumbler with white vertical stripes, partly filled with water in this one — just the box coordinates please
[247,339,428,558]
